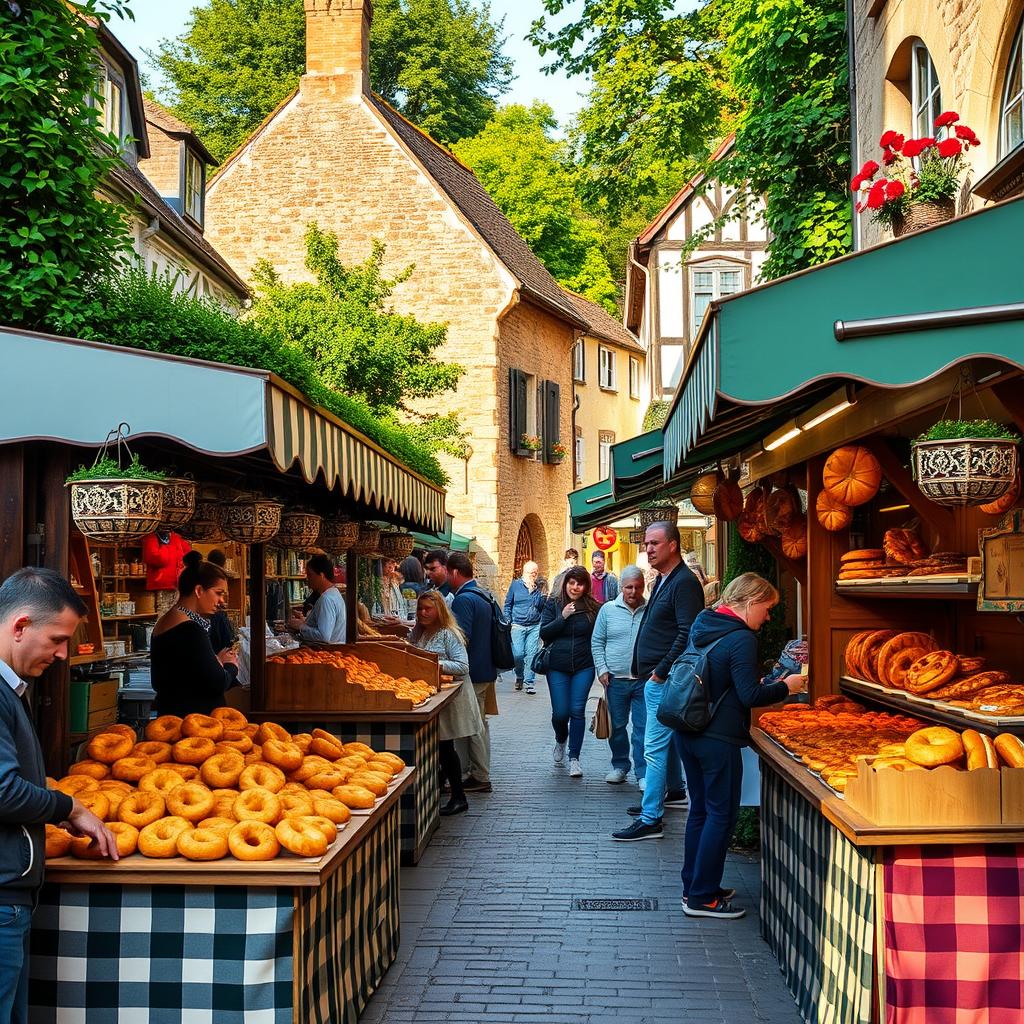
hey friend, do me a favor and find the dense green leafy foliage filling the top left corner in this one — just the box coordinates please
[0,0,129,333]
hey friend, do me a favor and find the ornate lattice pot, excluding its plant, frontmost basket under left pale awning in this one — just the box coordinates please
[68,477,165,543]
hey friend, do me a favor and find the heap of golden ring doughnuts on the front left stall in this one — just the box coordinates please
[46,708,406,861]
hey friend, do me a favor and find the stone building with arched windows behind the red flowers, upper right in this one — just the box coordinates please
[853,0,1024,248]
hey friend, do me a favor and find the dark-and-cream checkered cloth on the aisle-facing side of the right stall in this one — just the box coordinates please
[761,761,874,1024]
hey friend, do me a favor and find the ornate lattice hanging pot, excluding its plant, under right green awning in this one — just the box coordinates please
[912,437,1018,506]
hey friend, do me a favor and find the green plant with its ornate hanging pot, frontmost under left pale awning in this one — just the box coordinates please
[67,445,166,543]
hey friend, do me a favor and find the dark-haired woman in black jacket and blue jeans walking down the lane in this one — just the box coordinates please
[541,565,601,778]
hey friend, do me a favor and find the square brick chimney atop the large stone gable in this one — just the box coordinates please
[302,0,374,99]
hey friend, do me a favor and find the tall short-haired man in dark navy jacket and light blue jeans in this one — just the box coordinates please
[612,522,705,843]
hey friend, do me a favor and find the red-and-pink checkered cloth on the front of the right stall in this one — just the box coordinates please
[883,845,1024,1024]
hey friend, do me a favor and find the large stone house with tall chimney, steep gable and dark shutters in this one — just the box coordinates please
[201,0,586,589]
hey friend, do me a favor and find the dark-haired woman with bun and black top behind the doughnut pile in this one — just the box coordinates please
[150,552,239,717]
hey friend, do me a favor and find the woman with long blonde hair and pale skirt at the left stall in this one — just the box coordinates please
[409,590,483,816]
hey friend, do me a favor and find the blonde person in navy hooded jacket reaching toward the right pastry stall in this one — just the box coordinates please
[680,572,805,919]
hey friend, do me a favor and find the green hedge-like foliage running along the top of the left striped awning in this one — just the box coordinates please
[79,270,447,485]
